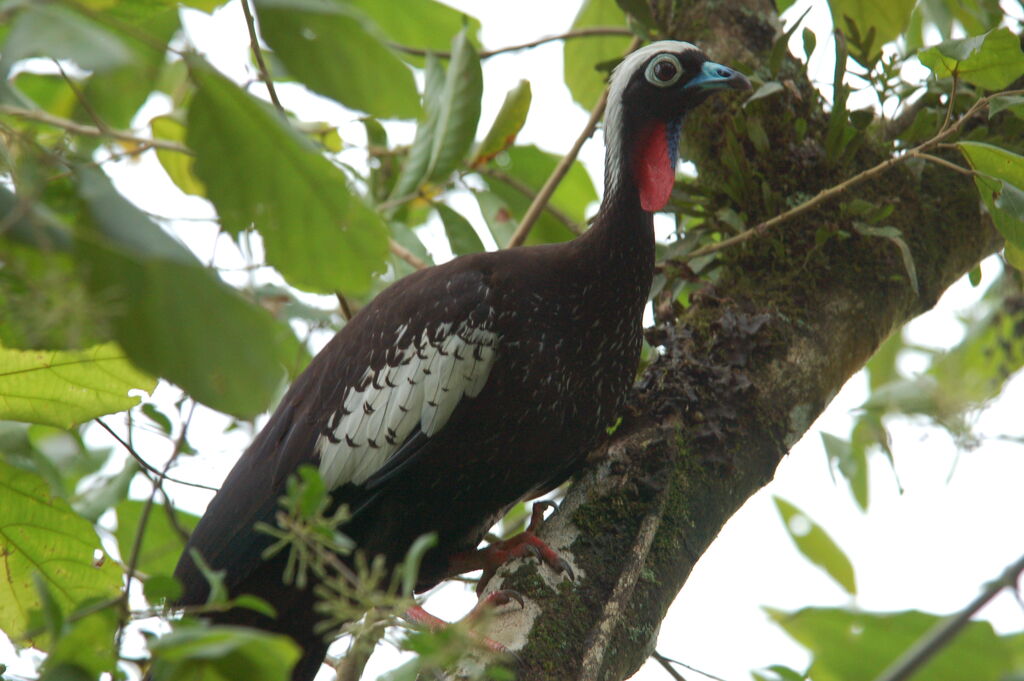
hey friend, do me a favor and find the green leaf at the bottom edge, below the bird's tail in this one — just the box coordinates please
[150,626,299,681]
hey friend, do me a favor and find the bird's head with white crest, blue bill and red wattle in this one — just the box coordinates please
[604,40,751,211]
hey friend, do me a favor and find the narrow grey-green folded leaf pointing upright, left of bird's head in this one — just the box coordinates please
[391,32,483,198]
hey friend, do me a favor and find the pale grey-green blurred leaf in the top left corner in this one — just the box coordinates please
[0,2,132,79]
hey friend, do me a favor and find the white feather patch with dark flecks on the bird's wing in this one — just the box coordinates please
[315,322,498,488]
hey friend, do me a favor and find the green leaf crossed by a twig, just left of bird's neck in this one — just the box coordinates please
[483,145,597,246]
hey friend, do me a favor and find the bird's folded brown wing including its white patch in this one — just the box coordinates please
[175,262,500,603]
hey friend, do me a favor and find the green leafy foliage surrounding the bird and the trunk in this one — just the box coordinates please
[0,0,1024,681]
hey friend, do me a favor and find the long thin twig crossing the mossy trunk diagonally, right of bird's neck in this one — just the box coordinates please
[680,90,1024,262]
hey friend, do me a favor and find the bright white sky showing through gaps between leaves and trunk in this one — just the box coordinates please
[0,0,1024,681]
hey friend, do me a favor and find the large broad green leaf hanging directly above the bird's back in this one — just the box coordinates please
[187,57,387,294]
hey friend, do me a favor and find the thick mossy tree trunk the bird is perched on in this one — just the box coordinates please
[455,0,1000,681]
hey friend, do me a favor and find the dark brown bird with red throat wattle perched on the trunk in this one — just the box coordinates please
[165,40,750,681]
